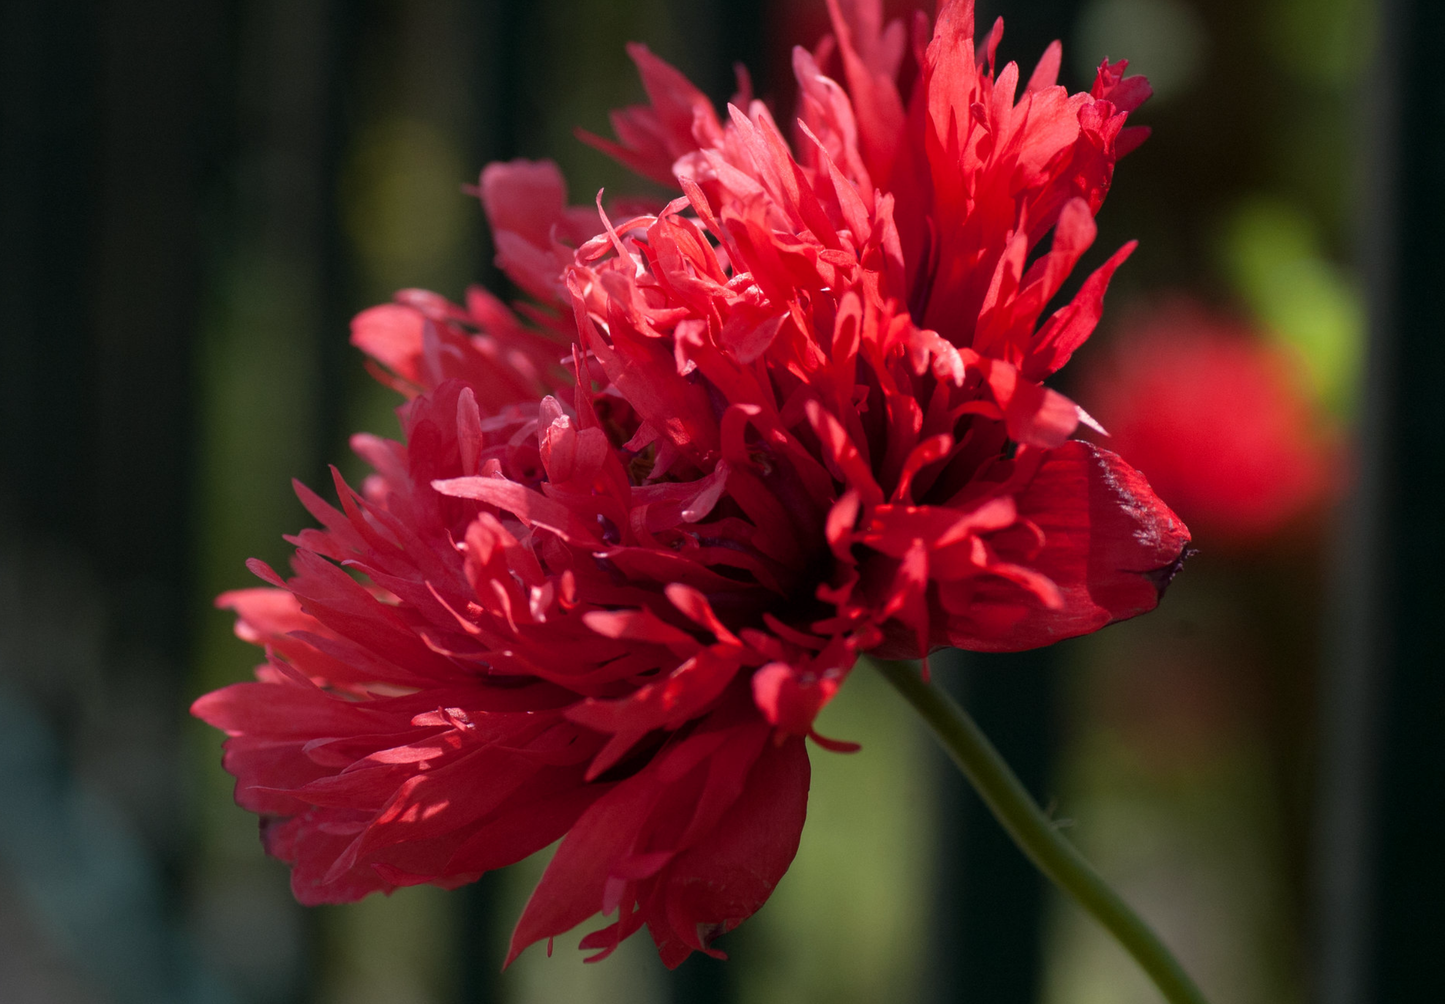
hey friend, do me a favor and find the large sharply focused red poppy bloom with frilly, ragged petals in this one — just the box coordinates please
[195,0,1188,966]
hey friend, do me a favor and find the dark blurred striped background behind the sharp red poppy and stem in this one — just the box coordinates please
[0,0,1445,1004]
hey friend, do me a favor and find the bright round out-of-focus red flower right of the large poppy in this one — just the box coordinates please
[1081,300,1345,548]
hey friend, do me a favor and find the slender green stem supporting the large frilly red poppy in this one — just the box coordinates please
[871,659,1207,1004]
